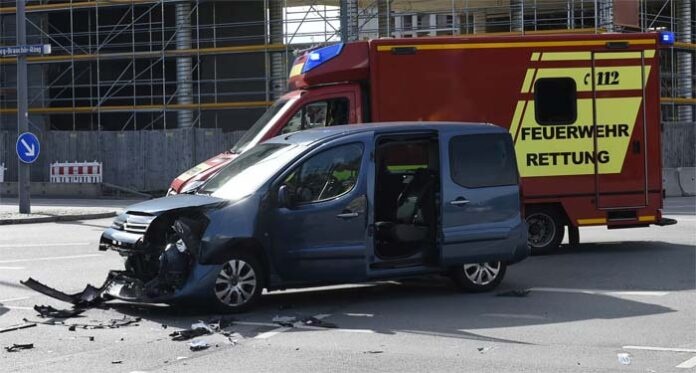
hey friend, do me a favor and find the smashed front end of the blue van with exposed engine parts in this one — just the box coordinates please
[99,196,217,302]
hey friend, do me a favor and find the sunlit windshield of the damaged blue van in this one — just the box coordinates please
[198,143,304,200]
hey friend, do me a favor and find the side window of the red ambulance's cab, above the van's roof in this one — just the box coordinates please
[281,97,348,134]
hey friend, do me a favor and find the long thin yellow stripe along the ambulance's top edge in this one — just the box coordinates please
[377,39,655,52]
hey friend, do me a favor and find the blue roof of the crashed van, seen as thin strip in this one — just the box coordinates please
[267,122,507,145]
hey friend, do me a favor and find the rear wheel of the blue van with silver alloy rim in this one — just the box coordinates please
[452,262,507,293]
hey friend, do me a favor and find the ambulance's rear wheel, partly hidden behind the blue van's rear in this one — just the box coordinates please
[526,207,565,255]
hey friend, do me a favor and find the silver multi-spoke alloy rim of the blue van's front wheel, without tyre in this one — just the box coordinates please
[215,259,258,308]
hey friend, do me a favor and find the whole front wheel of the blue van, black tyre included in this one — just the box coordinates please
[213,253,265,313]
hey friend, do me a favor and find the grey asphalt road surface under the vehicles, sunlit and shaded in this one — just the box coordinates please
[0,198,696,372]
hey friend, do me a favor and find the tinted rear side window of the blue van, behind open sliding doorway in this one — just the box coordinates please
[449,134,518,188]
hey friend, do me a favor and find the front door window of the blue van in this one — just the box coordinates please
[283,143,363,204]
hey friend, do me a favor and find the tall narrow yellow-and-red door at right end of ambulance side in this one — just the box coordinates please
[585,50,658,210]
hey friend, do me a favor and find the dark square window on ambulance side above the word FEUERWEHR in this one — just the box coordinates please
[534,78,578,125]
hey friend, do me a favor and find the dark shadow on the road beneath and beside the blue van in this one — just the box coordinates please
[100,242,696,343]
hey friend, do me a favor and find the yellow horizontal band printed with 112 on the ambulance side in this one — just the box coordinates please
[525,66,651,92]
